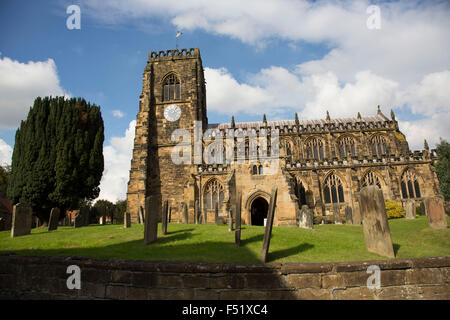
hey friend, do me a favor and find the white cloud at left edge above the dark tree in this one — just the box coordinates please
[0,57,65,129]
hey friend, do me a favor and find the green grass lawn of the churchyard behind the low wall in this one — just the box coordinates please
[0,216,450,263]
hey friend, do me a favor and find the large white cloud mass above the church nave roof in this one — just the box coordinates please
[81,0,450,148]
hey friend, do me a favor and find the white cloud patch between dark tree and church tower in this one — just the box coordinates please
[99,120,136,202]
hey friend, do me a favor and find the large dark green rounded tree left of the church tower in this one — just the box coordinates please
[8,97,104,221]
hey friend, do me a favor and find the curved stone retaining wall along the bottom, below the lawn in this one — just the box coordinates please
[0,255,450,300]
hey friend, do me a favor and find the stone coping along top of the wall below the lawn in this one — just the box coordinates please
[0,253,450,274]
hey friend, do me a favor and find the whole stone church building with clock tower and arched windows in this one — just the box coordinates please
[127,48,439,225]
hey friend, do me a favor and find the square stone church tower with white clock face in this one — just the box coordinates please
[127,48,208,222]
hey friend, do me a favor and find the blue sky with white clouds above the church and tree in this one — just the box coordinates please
[0,0,450,200]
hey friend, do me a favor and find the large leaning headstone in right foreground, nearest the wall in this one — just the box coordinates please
[360,185,395,258]
